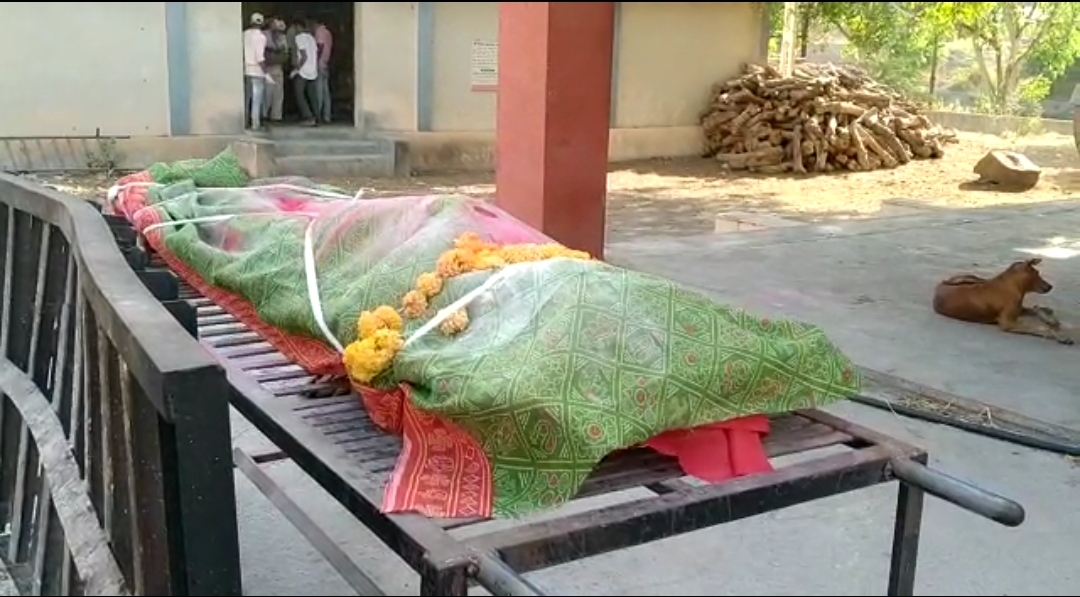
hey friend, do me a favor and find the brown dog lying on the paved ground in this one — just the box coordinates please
[934,258,1072,344]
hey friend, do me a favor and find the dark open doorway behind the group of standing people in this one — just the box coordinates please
[241,2,356,126]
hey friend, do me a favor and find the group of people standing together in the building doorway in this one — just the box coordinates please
[244,13,334,131]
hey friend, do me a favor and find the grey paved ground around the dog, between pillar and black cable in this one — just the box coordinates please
[609,203,1080,430]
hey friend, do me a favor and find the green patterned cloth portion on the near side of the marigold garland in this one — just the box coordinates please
[394,259,858,515]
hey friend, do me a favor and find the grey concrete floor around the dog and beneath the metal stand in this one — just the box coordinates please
[234,205,1080,595]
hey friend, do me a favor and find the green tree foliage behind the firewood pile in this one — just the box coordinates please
[769,2,1080,113]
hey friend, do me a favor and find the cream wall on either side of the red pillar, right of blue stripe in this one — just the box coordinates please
[423,2,762,132]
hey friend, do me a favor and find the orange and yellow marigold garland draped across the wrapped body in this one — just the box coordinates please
[342,232,592,385]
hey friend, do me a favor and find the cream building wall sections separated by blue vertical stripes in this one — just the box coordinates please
[0,2,761,136]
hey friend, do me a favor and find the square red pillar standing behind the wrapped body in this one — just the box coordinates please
[495,2,615,257]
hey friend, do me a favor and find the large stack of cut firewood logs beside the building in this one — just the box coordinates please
[701,64,956,174]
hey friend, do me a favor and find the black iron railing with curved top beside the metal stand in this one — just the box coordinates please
[0,174,241,595]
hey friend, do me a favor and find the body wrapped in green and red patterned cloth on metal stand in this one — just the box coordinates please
[112,150,859,516]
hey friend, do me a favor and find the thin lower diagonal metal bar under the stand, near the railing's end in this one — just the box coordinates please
[232,448,386,595]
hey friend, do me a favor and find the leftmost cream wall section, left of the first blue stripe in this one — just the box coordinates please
[0,2,168,137]
